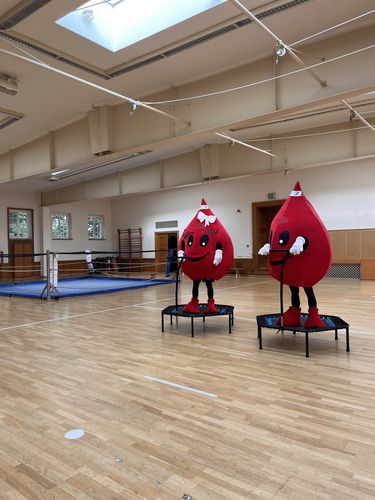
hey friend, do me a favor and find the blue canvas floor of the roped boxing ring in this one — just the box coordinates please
[0,276,175,299]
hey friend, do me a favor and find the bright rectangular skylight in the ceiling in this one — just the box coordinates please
[56,0,226,52]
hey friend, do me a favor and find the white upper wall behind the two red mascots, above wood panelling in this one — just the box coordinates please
[112,160,375,257]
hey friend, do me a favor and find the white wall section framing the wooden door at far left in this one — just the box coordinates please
[0,190,42,253]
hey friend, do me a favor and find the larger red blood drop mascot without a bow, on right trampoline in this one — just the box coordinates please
[259,182,332,328]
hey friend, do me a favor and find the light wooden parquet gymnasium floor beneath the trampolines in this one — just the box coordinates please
[0,276,375,500]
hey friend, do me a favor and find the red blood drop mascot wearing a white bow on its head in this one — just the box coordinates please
[178,199,233,313]
